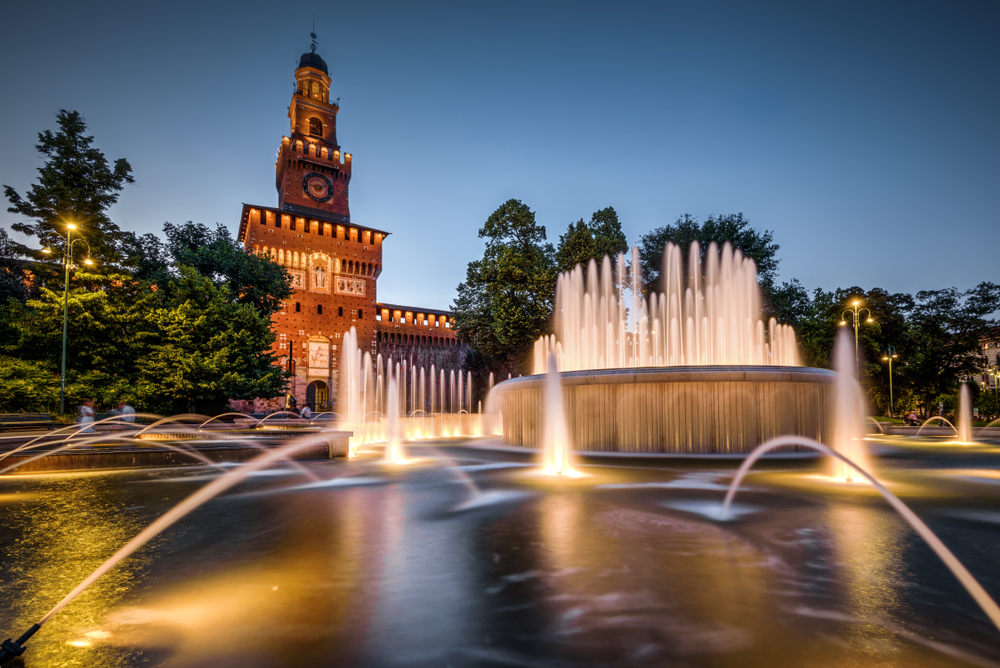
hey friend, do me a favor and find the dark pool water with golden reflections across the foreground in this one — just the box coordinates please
[0,437,1000,668]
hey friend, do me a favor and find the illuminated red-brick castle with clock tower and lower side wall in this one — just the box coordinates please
[239,45,465,410]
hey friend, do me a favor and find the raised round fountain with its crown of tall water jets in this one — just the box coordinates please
[491,243,836,454]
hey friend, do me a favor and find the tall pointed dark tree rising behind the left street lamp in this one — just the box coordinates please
[4,109,135,267]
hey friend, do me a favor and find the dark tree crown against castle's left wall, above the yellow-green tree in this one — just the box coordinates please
[158,221,292,315]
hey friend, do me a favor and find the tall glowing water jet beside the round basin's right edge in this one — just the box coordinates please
[831,329,871,482]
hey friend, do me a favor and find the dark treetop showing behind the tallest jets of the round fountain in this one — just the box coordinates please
[638,213,781,294]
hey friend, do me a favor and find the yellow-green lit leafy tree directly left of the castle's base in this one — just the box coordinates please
[136,266,286,412]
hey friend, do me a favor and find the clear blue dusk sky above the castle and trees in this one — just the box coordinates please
[0,0,1000,308]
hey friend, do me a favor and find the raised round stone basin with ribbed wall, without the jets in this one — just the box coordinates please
[493,366,836,454]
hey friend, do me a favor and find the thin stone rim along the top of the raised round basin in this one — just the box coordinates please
[493,365,837,392]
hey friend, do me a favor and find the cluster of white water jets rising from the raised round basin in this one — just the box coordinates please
[534,242,799,374]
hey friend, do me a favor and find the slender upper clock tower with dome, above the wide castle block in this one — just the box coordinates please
[274,42,351,222]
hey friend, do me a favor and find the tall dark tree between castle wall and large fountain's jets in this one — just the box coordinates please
[452,199,556,378]
